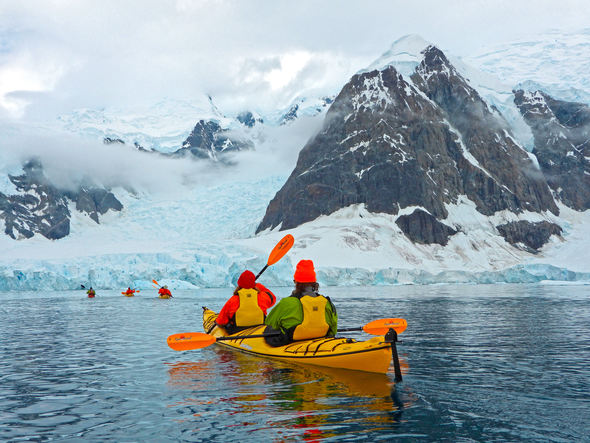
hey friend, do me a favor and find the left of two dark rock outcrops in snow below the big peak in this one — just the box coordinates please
[395,209,458,246]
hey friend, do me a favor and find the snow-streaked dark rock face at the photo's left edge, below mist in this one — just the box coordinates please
[0,161,123,240]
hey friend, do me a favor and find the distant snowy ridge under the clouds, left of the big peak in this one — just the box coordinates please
[59,95,332,154]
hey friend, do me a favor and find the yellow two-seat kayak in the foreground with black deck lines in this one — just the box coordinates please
[203,307,392,374]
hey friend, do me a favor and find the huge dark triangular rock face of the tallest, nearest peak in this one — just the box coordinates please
[257,46,558,243]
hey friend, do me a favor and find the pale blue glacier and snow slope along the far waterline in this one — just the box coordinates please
[0,175,590,291]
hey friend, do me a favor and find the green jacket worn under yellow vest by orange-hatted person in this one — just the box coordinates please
[264,294,338,337]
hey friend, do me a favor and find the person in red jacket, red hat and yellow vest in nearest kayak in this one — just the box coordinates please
[216,270,277,334]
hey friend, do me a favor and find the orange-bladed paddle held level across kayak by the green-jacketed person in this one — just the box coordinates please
[166,318,408,351]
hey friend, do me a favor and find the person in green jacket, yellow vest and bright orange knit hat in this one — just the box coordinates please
[264,260,338,346]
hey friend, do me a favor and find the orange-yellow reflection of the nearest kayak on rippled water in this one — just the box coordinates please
[168,348,415,440]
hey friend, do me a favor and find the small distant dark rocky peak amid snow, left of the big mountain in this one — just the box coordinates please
[174,120,254,160]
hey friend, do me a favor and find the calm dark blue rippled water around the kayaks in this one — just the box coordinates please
[0,285,590,442]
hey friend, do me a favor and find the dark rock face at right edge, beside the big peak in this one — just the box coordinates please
[514,90,590,211]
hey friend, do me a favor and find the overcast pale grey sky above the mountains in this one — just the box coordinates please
[0,0,590,121]
